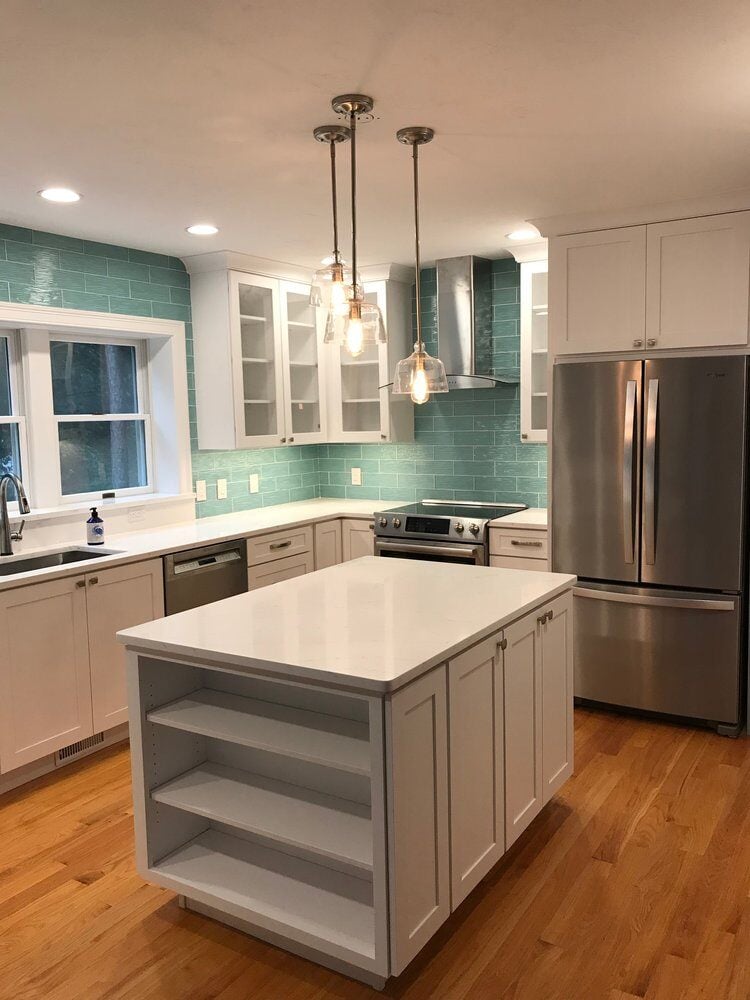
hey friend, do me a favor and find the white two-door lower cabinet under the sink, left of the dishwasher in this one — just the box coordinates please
[0,559,164,773]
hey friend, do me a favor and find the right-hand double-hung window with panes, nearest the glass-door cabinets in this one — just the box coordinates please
[49,336,152,500]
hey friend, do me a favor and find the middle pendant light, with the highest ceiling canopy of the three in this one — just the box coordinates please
[323,94,385,358]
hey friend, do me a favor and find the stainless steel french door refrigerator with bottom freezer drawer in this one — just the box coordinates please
[552,356,747,734]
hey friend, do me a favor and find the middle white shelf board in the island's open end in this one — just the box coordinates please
[151,761,372,875]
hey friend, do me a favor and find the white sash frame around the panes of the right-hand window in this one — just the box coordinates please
[47,332,154,505]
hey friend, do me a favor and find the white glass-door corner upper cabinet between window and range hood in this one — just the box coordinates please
[188,255,414,449]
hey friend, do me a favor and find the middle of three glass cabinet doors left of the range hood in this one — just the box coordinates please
[280,281,327,444]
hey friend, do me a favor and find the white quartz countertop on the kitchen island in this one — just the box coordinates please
[118,556,576,694]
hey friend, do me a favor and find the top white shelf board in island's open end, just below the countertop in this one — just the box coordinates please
[147,688,370,775]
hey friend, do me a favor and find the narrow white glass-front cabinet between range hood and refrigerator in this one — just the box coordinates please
[520,260,549,442]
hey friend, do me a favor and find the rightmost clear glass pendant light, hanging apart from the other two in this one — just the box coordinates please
[393,125,448,403]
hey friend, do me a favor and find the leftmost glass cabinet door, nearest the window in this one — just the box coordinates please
[233,274,284,443]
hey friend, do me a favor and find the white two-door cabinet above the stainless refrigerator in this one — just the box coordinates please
[550,212,750,354]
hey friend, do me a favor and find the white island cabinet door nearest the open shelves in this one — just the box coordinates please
[386,667,450,976]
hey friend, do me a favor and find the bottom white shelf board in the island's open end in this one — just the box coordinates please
[150,830,375,964]
